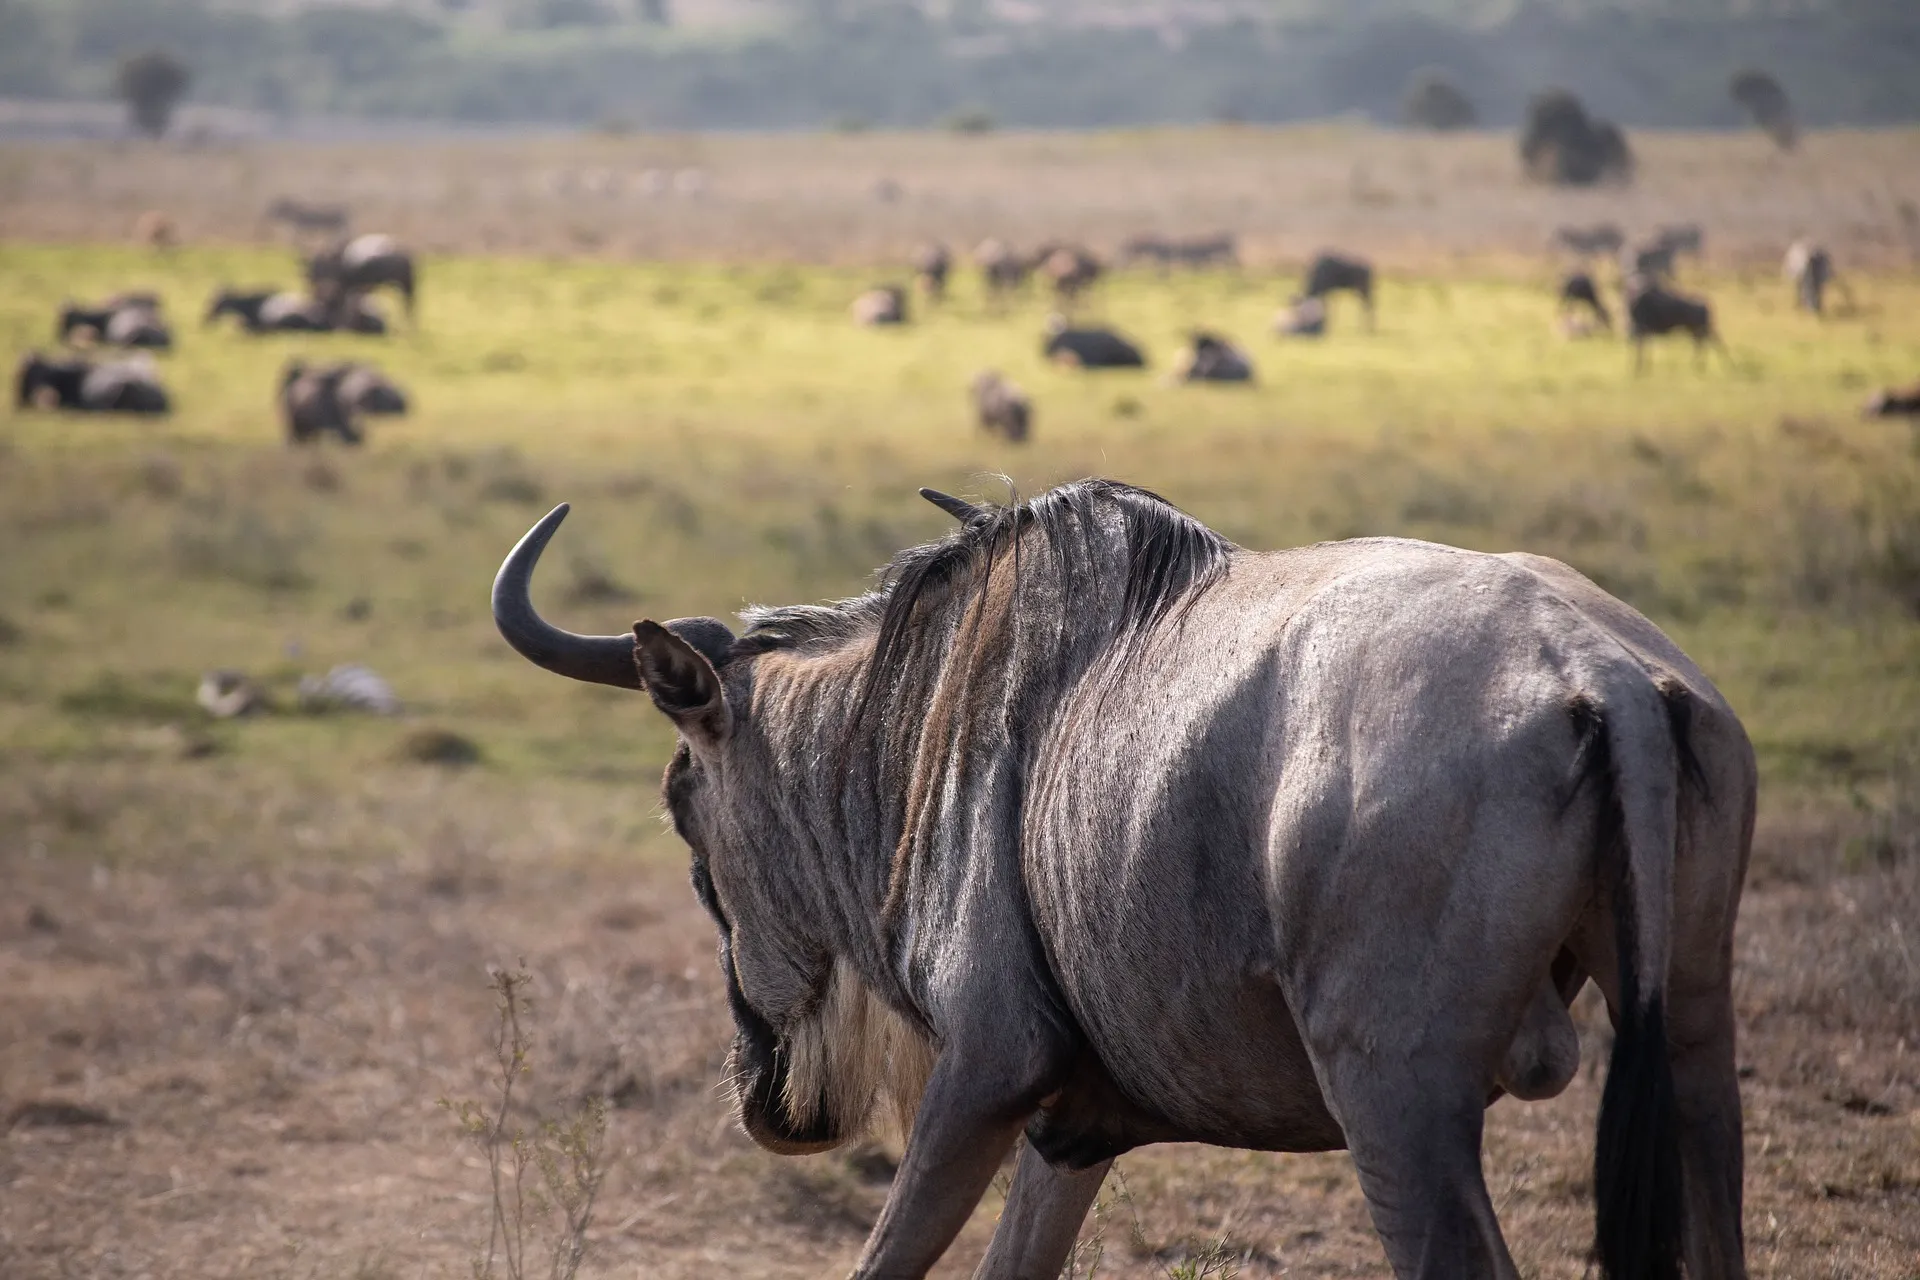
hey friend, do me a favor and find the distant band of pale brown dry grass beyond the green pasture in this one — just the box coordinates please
[0,125,1920,269]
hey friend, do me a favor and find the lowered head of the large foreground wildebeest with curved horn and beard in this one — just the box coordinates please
[493,505,964,1153]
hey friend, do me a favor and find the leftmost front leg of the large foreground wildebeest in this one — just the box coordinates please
[852,1048,1041,1280]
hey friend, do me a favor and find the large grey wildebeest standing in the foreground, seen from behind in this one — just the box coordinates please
[493,480,1755,1280]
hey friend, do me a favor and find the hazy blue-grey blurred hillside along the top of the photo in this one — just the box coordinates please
[0,0,1920,129]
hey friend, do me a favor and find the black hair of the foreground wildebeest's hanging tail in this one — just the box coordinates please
[1586,702,1697,1280]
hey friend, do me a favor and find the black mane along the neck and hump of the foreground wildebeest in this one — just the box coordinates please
[733,480,1231,679]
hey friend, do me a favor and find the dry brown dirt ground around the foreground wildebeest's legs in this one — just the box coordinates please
[0,764,1920,1280]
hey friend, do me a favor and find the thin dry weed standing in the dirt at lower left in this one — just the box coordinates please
[440,969,607,1280]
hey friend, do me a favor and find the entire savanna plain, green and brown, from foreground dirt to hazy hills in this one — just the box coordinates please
[0,130,1920,1280]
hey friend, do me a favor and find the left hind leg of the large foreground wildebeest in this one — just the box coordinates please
[1327,1046,1519,1280]
